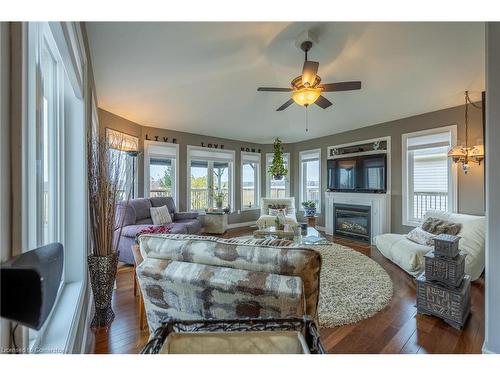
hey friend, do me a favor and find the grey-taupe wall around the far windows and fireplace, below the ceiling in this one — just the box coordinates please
[99,101,484,233]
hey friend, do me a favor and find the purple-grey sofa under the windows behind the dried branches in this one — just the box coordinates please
[114,197,201,264]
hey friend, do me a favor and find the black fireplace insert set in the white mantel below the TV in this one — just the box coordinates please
[333,203,371,243]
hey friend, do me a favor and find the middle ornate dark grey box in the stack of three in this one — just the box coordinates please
[425,251,466,288]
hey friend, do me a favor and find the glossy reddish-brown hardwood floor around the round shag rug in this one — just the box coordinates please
[95,228,484,354]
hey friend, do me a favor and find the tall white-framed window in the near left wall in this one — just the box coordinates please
[25,22,88,351]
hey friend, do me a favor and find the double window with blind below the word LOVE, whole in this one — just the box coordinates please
[187,146,234,210]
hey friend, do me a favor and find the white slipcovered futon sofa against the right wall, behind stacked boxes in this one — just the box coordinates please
[373,211,486,281]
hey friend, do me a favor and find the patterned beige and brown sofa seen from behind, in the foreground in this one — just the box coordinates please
[136,234,321,332]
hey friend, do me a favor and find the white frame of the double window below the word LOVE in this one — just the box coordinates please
[186,145,236,213]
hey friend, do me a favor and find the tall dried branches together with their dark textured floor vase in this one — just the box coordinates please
[87,136,133,329]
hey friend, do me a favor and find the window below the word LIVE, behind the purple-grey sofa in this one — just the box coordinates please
[144,141,179,207]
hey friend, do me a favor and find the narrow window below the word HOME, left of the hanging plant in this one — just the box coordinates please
[241,152,261,210]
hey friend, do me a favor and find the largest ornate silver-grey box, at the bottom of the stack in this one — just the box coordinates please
[417,274,470,329]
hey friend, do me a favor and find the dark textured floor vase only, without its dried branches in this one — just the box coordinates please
[87,251,120,329]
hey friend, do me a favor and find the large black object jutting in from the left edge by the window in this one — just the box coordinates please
[0,242,64,330]
